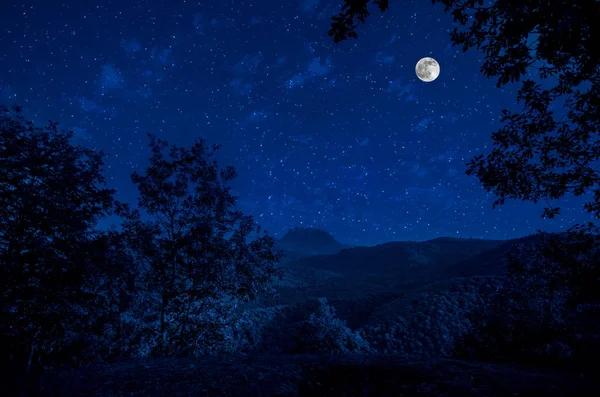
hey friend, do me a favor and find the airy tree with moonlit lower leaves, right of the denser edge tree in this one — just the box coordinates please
[118,135,280,355]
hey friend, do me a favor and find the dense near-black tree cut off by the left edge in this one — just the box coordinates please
[0,105,113,368]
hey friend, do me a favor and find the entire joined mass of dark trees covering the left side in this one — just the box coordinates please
[0,106,281,370]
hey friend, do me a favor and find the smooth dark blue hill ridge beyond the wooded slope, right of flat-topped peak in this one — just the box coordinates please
[270,229,596,304]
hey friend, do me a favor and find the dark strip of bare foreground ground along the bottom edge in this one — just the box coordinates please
[10,355,600,397]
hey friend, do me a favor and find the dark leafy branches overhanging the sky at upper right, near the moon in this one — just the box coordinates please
[329,0,600,218]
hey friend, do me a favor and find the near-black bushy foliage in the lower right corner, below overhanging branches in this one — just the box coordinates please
[456,225,600,365]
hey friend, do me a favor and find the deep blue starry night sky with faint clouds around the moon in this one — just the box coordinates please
[0,0,589,245]
